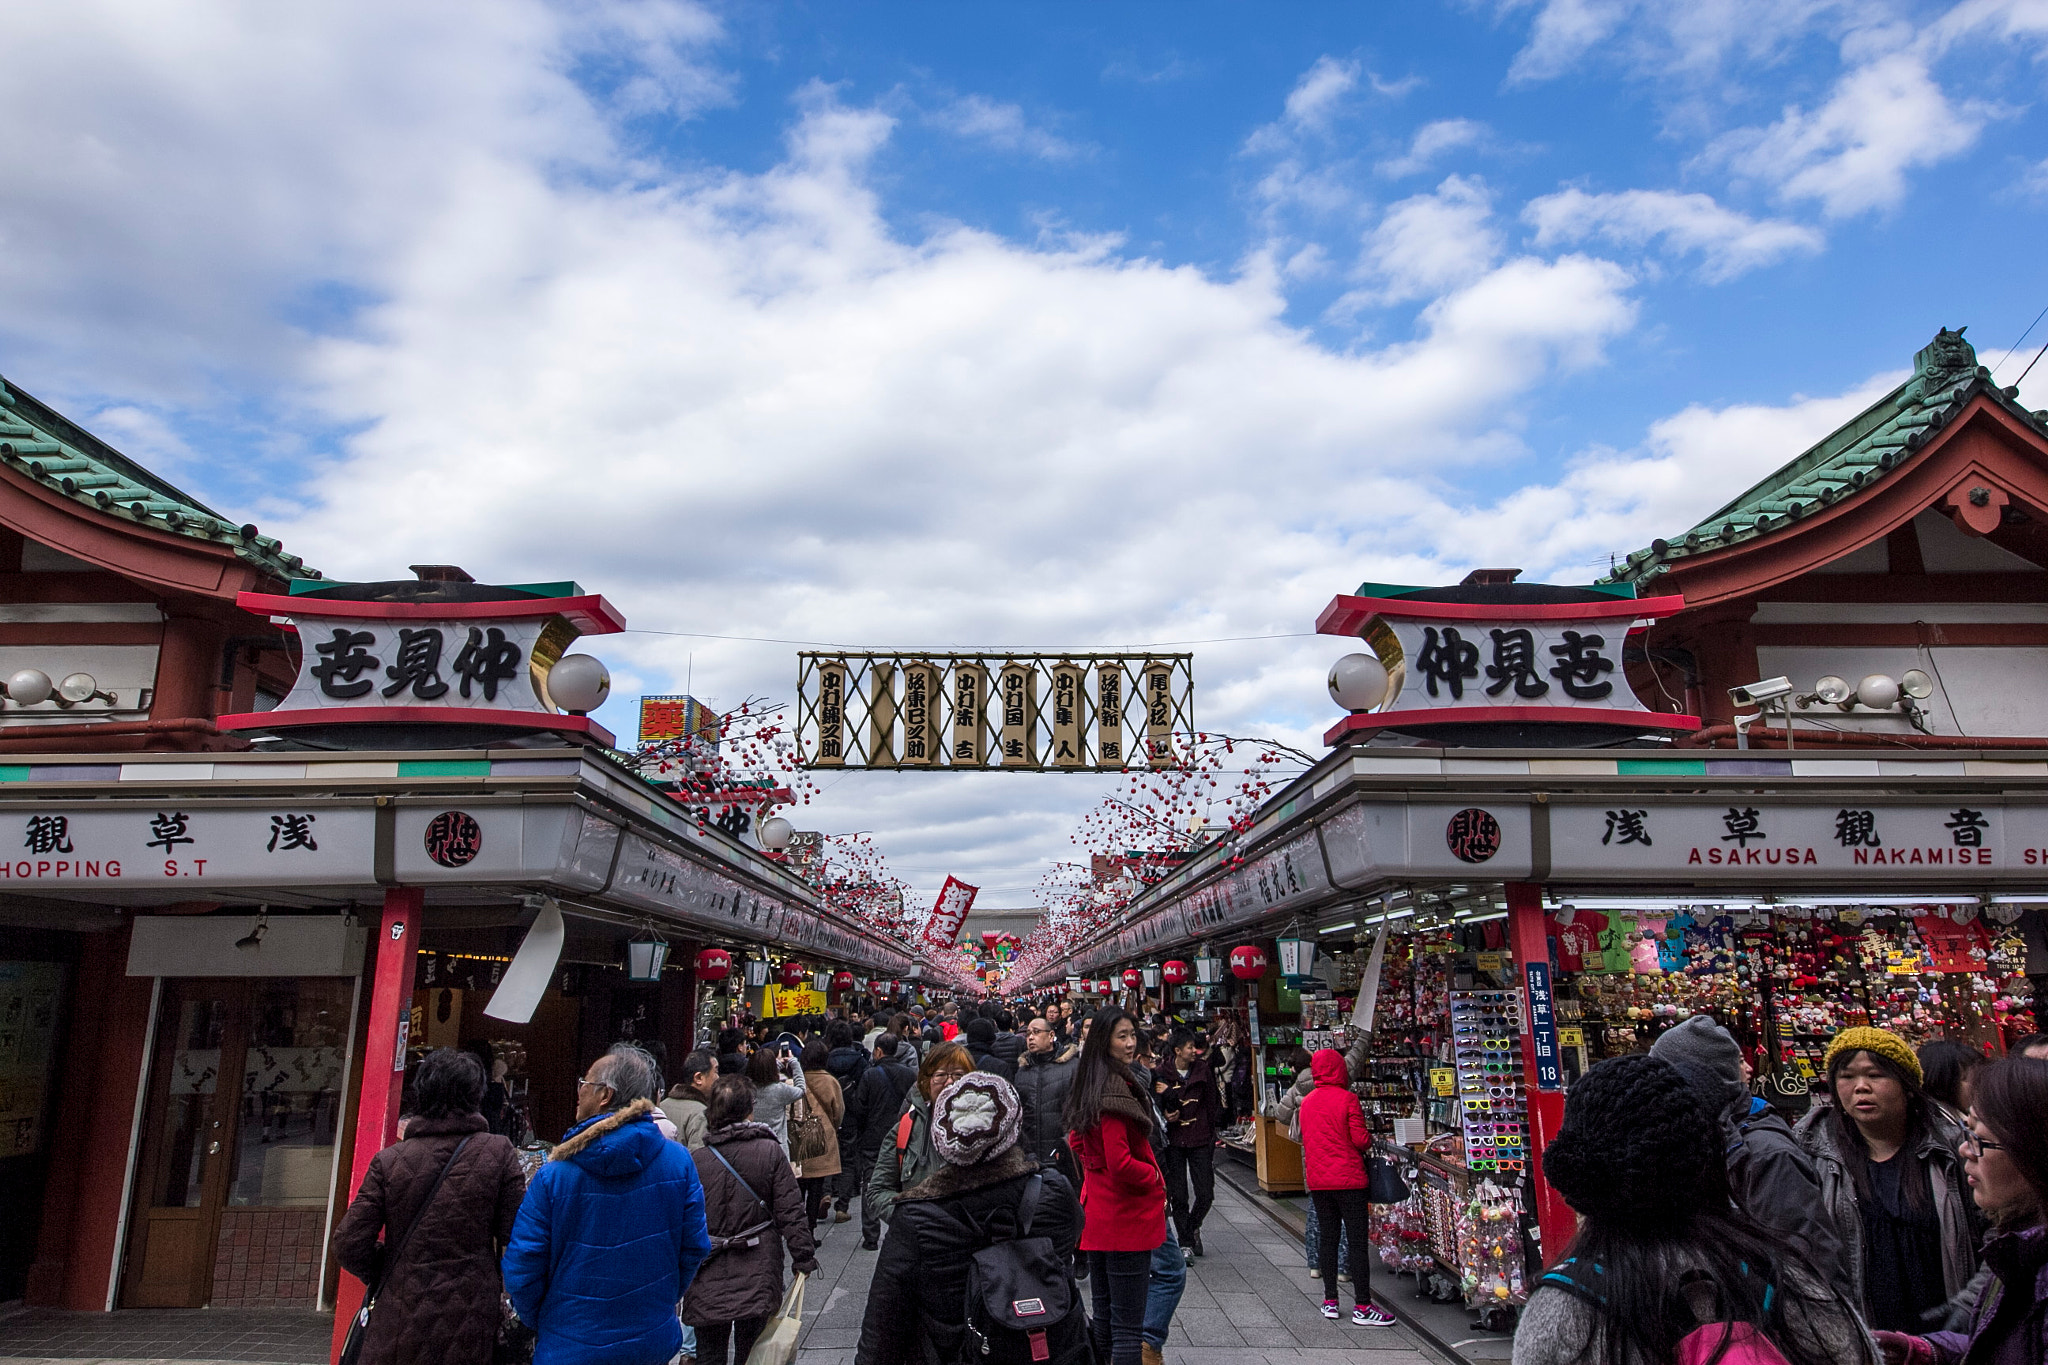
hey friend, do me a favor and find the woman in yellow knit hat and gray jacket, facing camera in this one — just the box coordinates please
[1796,1027,1982,1332]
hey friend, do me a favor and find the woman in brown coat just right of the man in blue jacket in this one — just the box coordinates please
[682,1076,817,1365]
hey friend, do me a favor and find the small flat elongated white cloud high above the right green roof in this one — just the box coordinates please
[1522,188,1825,282]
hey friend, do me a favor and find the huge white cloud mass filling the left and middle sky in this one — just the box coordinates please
[0,0,1655,908]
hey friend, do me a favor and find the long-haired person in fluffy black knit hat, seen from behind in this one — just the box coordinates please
[1513,1054,1880,1365]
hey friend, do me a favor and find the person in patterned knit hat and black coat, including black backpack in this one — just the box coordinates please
[854,1070,1090,1365]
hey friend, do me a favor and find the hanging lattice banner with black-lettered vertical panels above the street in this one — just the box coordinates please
[797,651,1194,772]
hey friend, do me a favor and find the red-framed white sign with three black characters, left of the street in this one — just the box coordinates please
[219,593,625,731]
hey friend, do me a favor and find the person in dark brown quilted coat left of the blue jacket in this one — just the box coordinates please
[334,1048,526,1365]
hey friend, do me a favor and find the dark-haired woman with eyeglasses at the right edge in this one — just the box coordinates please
[1878,1056,2048,1365]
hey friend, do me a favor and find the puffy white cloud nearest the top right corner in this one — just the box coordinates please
[1708,49,1993,217]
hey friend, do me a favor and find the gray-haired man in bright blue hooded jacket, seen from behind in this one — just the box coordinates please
[504,1044,711,1365]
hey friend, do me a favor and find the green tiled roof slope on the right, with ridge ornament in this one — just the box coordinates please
[1602,327,2048,583]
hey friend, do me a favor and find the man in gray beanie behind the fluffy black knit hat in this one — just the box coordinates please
[1651,1015,1853,1302]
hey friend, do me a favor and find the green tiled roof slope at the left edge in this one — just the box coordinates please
[0,379,319,579]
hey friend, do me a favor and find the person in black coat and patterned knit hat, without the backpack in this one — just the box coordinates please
[854,1070,1087,1365]
